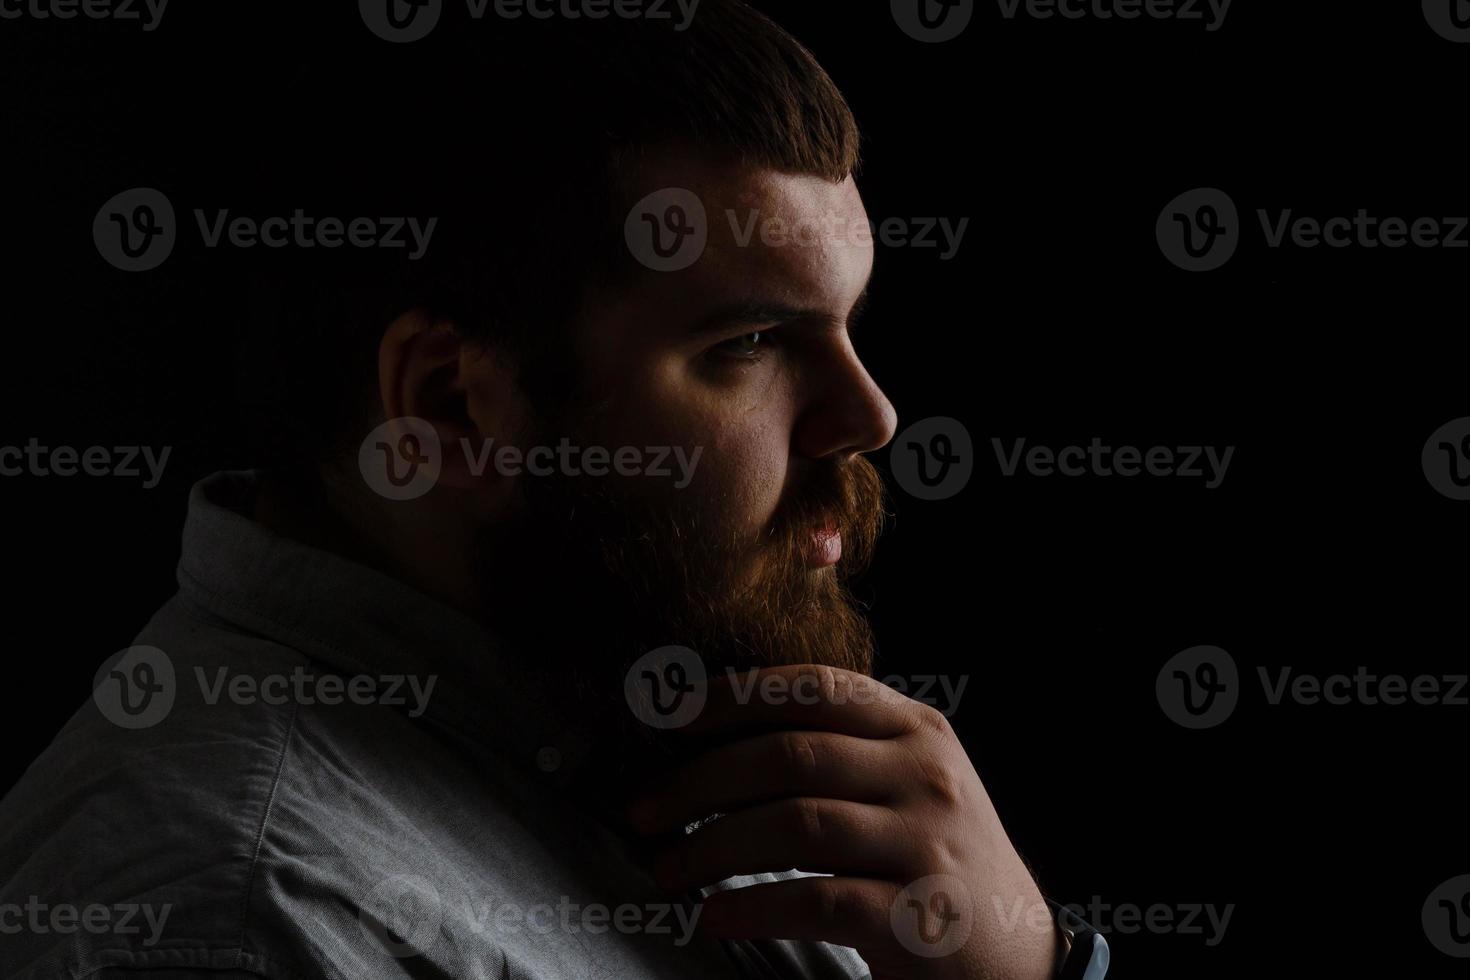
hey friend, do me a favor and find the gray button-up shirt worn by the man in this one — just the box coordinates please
[0,472,867,980]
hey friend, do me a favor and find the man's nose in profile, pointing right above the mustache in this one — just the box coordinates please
[792,336,898,460]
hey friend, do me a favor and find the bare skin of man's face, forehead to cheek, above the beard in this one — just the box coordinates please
[581,145,894,558]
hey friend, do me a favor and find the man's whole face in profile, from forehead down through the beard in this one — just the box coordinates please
[481,154,895,734]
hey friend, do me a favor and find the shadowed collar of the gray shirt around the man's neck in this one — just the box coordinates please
[178,470,592,785]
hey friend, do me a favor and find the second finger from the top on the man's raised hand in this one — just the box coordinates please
[628,732,898,833]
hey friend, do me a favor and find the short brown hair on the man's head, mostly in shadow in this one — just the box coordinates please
[240,0,858,469]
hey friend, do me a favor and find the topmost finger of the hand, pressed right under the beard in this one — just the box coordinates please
[679,664,929,739]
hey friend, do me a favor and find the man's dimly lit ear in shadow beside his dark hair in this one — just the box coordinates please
[378,310,523,489]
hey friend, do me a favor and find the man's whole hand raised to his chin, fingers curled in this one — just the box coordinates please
[628,664,1058,980]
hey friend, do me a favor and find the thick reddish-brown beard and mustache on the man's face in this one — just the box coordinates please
[475,393,885,777]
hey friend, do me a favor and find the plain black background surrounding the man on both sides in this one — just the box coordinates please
[0,0,1470,979]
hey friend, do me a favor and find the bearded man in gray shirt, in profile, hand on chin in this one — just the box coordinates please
[0,0,1100,980]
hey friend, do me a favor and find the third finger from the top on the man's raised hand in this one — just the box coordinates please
[653,796,920,892]
